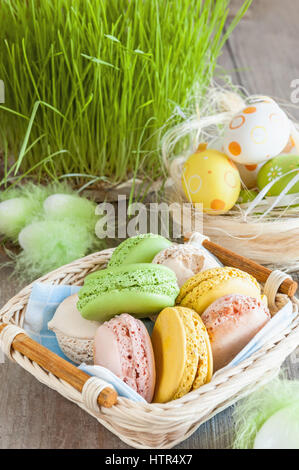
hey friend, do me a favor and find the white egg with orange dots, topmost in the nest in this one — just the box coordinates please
[223,97,291,165]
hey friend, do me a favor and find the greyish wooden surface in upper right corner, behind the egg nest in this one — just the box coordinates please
[229,0,299,118]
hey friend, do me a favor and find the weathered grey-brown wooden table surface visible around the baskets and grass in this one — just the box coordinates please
[0,0,299,449]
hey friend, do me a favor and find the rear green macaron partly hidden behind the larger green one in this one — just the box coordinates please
[108,233,172,268]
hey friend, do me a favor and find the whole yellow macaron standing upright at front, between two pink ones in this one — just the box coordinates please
[152,307,213,403]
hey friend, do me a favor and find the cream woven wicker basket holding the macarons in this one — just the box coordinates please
[0,246,299,449]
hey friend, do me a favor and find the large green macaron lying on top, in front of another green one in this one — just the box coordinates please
[77,263,179,322]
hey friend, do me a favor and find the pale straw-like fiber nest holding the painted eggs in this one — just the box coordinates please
[162,82,299,271]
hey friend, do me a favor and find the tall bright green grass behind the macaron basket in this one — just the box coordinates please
[0,0,251,189]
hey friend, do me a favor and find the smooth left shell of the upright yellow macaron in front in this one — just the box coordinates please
[152,309,187,403]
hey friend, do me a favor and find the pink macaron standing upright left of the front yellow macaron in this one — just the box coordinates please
[94,313,156,402]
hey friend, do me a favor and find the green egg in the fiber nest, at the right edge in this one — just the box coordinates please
[257,154,299,196]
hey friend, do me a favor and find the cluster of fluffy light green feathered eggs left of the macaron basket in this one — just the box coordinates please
[0,183,105,281]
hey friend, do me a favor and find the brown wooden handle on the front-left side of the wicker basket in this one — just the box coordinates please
[0,323,118,408]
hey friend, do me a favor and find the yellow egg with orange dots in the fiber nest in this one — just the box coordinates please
[182,149,241,214]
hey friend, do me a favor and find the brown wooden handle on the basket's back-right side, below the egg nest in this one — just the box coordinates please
[185,233,298,297]
